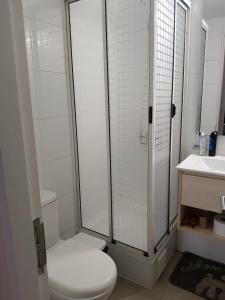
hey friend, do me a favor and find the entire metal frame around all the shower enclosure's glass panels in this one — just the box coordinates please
[65,0,191,259]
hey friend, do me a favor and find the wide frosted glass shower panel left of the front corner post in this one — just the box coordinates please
[107,0,149,250]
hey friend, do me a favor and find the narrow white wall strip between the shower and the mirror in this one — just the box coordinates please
[182,0,202,158]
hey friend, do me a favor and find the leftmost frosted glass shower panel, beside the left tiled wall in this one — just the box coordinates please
[69,0,109,235]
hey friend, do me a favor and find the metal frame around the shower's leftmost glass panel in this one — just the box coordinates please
[65,0,113,242]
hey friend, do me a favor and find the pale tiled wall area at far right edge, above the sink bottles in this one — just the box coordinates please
[202,17,225,134]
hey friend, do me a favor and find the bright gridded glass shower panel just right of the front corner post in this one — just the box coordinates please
[154,0,175,246]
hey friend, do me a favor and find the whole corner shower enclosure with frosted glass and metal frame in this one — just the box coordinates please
[67,0,188,257]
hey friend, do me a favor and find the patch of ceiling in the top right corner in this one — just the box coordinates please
[202,0,225,19]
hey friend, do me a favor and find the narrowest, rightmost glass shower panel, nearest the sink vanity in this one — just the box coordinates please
[170,3,186,223]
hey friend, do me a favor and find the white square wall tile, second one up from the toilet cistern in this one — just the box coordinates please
[40,117,71,162]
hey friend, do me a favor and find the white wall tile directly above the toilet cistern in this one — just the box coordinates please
[44,156,74,197]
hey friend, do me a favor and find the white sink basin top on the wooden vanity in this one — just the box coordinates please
[177,154,225,176]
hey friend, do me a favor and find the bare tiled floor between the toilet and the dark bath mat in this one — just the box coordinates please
[110,253,202,300]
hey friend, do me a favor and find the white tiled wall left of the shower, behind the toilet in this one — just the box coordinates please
[23,0,75,236]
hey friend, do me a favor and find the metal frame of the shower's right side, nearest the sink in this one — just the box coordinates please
[148,0,192,256]
